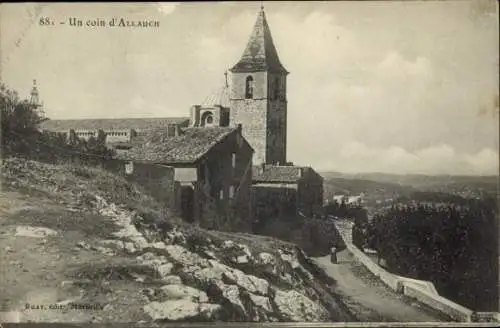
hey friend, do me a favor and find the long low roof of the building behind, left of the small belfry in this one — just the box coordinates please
[41,117,189,131]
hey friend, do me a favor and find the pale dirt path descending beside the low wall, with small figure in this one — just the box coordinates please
[313,250,445,322]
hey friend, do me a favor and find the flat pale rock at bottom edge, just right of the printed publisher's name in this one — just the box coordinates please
[144,299,221,321]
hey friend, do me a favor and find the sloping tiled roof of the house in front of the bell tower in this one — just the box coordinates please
[119,127,238,164]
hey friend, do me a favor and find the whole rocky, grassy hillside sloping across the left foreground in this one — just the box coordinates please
[0,158,352,322]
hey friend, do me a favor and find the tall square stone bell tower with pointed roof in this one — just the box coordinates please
[230,7,288,165]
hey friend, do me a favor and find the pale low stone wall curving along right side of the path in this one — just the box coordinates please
[335,219,500,322]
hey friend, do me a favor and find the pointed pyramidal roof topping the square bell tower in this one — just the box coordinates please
[231,10,287,73]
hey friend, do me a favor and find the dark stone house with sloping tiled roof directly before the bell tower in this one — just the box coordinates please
[119,126,253,231]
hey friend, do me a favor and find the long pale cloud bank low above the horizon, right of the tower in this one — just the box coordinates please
[319,141,499,175]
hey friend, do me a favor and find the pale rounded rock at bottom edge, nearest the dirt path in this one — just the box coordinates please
[273,289,329,322]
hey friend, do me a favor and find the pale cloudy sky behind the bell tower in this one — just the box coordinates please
[0,0,499,175]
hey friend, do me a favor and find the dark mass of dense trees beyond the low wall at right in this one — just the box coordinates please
[367,197,498,311]
